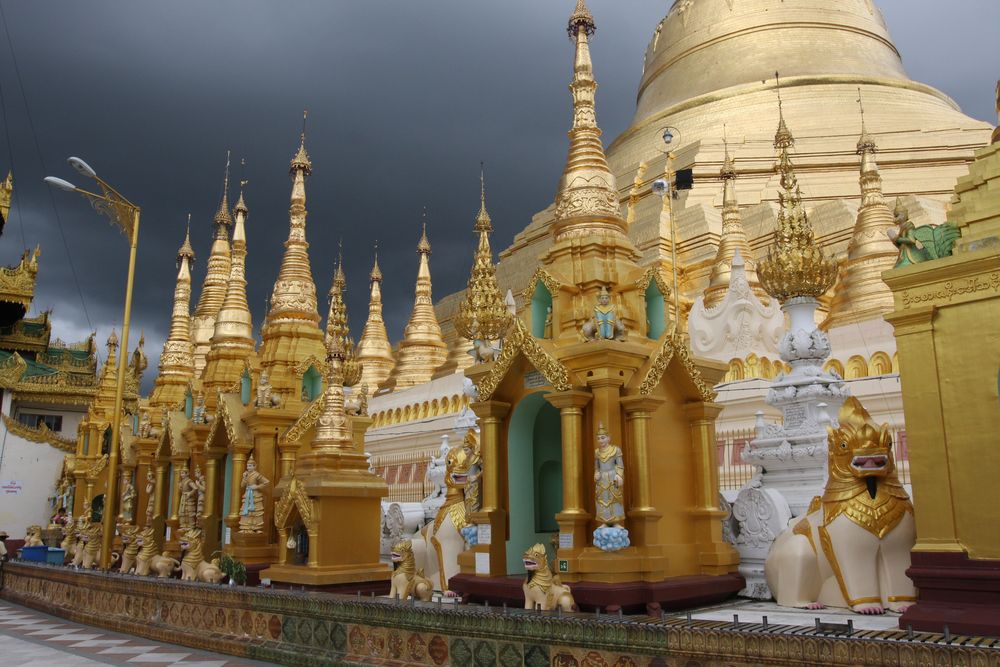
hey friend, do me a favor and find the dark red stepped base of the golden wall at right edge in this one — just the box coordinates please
[899,552,1000,637]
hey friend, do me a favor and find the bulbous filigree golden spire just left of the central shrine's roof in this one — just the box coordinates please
[455,169,510,341]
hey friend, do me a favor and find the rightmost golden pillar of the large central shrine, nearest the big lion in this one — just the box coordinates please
[684,402,740,575]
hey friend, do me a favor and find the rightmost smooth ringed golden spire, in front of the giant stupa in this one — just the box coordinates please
[824,88,899,328]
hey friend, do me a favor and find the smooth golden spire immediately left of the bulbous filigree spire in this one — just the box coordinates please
[395,217,448,388]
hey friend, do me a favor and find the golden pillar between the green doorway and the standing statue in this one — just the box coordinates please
[545,390,594,570]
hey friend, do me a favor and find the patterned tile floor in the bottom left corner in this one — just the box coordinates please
[0,600,271,667]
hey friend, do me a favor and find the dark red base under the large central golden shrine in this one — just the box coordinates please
[448,573,745,615]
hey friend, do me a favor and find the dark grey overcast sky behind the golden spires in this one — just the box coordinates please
[0,0,1000,387]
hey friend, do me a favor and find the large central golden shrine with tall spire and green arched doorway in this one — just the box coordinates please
[449,0,742,608]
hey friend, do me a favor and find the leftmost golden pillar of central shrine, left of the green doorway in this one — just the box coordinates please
[468,401,510,577]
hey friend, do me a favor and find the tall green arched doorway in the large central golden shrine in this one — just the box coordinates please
[507,392,563,574]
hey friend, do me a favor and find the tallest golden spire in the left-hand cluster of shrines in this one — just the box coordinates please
[260,119,326,401]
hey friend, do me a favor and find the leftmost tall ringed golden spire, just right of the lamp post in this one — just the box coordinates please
[149,220,194,412]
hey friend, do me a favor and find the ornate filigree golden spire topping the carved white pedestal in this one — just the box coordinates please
[757,73,837,304]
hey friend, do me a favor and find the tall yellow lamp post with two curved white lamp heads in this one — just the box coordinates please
[45,157,140,570]
